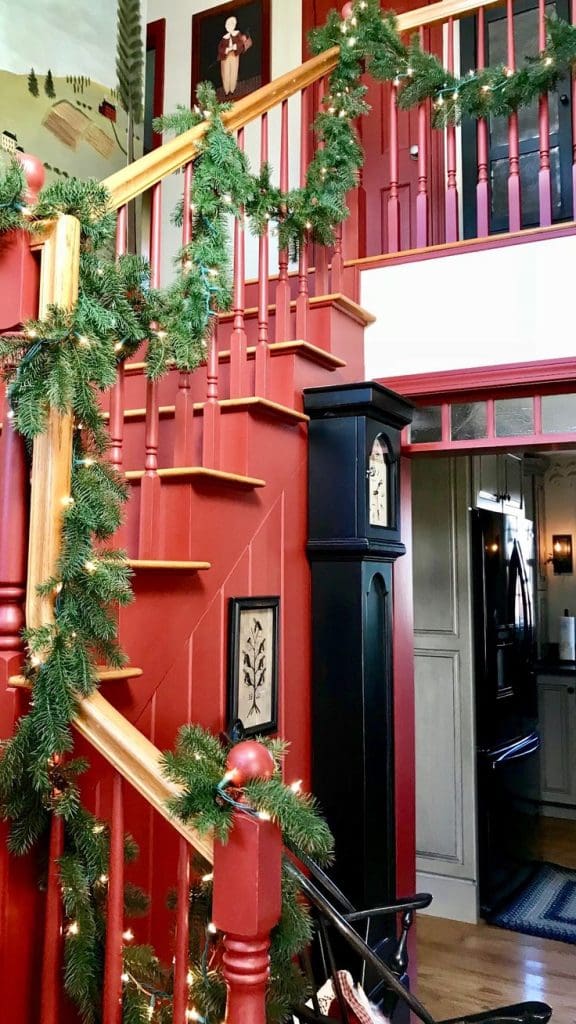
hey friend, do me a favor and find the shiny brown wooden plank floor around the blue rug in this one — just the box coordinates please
[417,818,576,1024]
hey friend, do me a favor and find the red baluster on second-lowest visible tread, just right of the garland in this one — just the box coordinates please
[138,183,162,558]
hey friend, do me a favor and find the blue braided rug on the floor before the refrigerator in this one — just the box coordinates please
[490,863,576,944]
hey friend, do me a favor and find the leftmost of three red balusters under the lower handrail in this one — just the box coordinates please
[40,814,64,1024]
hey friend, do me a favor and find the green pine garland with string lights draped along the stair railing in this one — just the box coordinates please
[0,0,576,1024]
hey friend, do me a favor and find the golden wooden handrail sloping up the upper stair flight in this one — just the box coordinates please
[102,0,503,210]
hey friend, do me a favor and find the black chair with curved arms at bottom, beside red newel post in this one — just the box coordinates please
[286,860,552,1024]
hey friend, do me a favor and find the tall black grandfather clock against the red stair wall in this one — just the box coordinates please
[304,382,413,907]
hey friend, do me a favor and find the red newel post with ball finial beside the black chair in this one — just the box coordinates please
[212,740,282,1024]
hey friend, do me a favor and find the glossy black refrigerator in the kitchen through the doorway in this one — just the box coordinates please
[471,509,540,918]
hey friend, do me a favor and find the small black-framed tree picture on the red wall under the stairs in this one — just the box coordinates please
[228,597,280,736]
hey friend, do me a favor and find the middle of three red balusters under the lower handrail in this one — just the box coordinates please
[102,772,124,1024]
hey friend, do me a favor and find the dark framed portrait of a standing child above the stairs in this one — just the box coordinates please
[192,0,271,105]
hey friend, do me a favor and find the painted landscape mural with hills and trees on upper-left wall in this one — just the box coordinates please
[0,0,146,181]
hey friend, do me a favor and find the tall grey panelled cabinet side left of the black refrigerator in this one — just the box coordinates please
[412,457,477,921]
